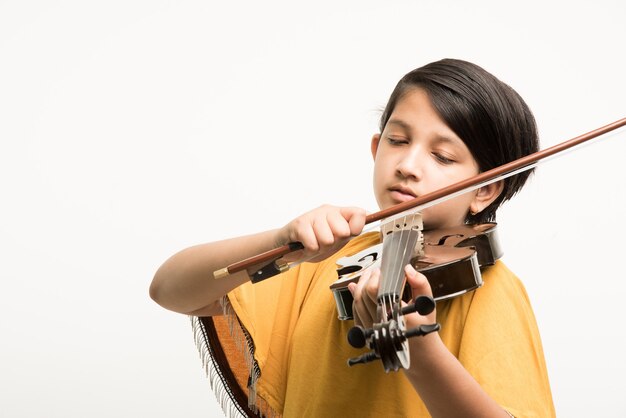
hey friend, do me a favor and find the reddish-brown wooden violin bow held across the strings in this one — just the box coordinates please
[213,118,626,283]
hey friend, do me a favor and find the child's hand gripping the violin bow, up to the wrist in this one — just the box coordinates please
[276,205,366,262]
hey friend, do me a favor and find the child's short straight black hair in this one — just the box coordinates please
[380,59,539,223]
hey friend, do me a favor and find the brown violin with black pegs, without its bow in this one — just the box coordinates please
[330,213,502,372]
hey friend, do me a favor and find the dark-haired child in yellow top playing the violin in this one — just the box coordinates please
[150,59,554,417]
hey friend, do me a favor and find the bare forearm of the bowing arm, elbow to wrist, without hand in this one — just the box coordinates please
[150,230,277,314]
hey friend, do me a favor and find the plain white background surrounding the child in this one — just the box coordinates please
[0,0,626,417]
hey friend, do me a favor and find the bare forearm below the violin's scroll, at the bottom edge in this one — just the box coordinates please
[405,334,510,418]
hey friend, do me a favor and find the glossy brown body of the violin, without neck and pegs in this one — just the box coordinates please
[330,223,502,320]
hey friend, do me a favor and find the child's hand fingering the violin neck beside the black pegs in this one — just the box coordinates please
[348,264,437,329]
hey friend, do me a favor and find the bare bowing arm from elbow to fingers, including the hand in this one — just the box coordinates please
[150,205,365,316]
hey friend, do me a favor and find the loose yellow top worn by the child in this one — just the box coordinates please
[228,234,555,418]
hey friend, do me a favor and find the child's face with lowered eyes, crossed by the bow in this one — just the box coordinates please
[372,89,488,229]
